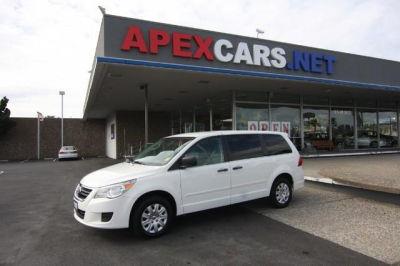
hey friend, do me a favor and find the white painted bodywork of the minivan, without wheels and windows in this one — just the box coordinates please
[74,131,304,235]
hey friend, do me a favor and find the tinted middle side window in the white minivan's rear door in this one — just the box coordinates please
[226,134,264,161]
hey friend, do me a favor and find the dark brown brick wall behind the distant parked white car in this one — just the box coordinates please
[0,118,105,160]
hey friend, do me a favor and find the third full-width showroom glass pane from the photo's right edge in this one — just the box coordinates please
[331,108,354,150]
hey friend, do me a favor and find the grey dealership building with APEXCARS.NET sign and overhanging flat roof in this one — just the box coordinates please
[84,15,400,158]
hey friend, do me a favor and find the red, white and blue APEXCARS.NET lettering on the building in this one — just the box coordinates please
[121,26,336,74]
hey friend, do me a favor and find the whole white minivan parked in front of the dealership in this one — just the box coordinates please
[74,131,304,237]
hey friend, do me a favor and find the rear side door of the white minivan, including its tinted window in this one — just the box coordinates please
[224,134,273,204]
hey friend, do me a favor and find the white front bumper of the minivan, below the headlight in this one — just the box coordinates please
[74,189,135,229]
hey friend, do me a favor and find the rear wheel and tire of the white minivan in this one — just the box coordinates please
[269,177,293,208]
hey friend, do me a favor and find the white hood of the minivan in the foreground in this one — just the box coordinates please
[81,163,161,188]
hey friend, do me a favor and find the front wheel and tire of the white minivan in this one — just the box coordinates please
[131,195,175,237]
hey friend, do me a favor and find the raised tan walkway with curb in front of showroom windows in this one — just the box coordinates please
[303,154,400,194]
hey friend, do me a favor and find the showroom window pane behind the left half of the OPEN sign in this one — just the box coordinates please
[236,103,268,130]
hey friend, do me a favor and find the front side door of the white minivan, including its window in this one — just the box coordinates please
[179,137,230,213]
